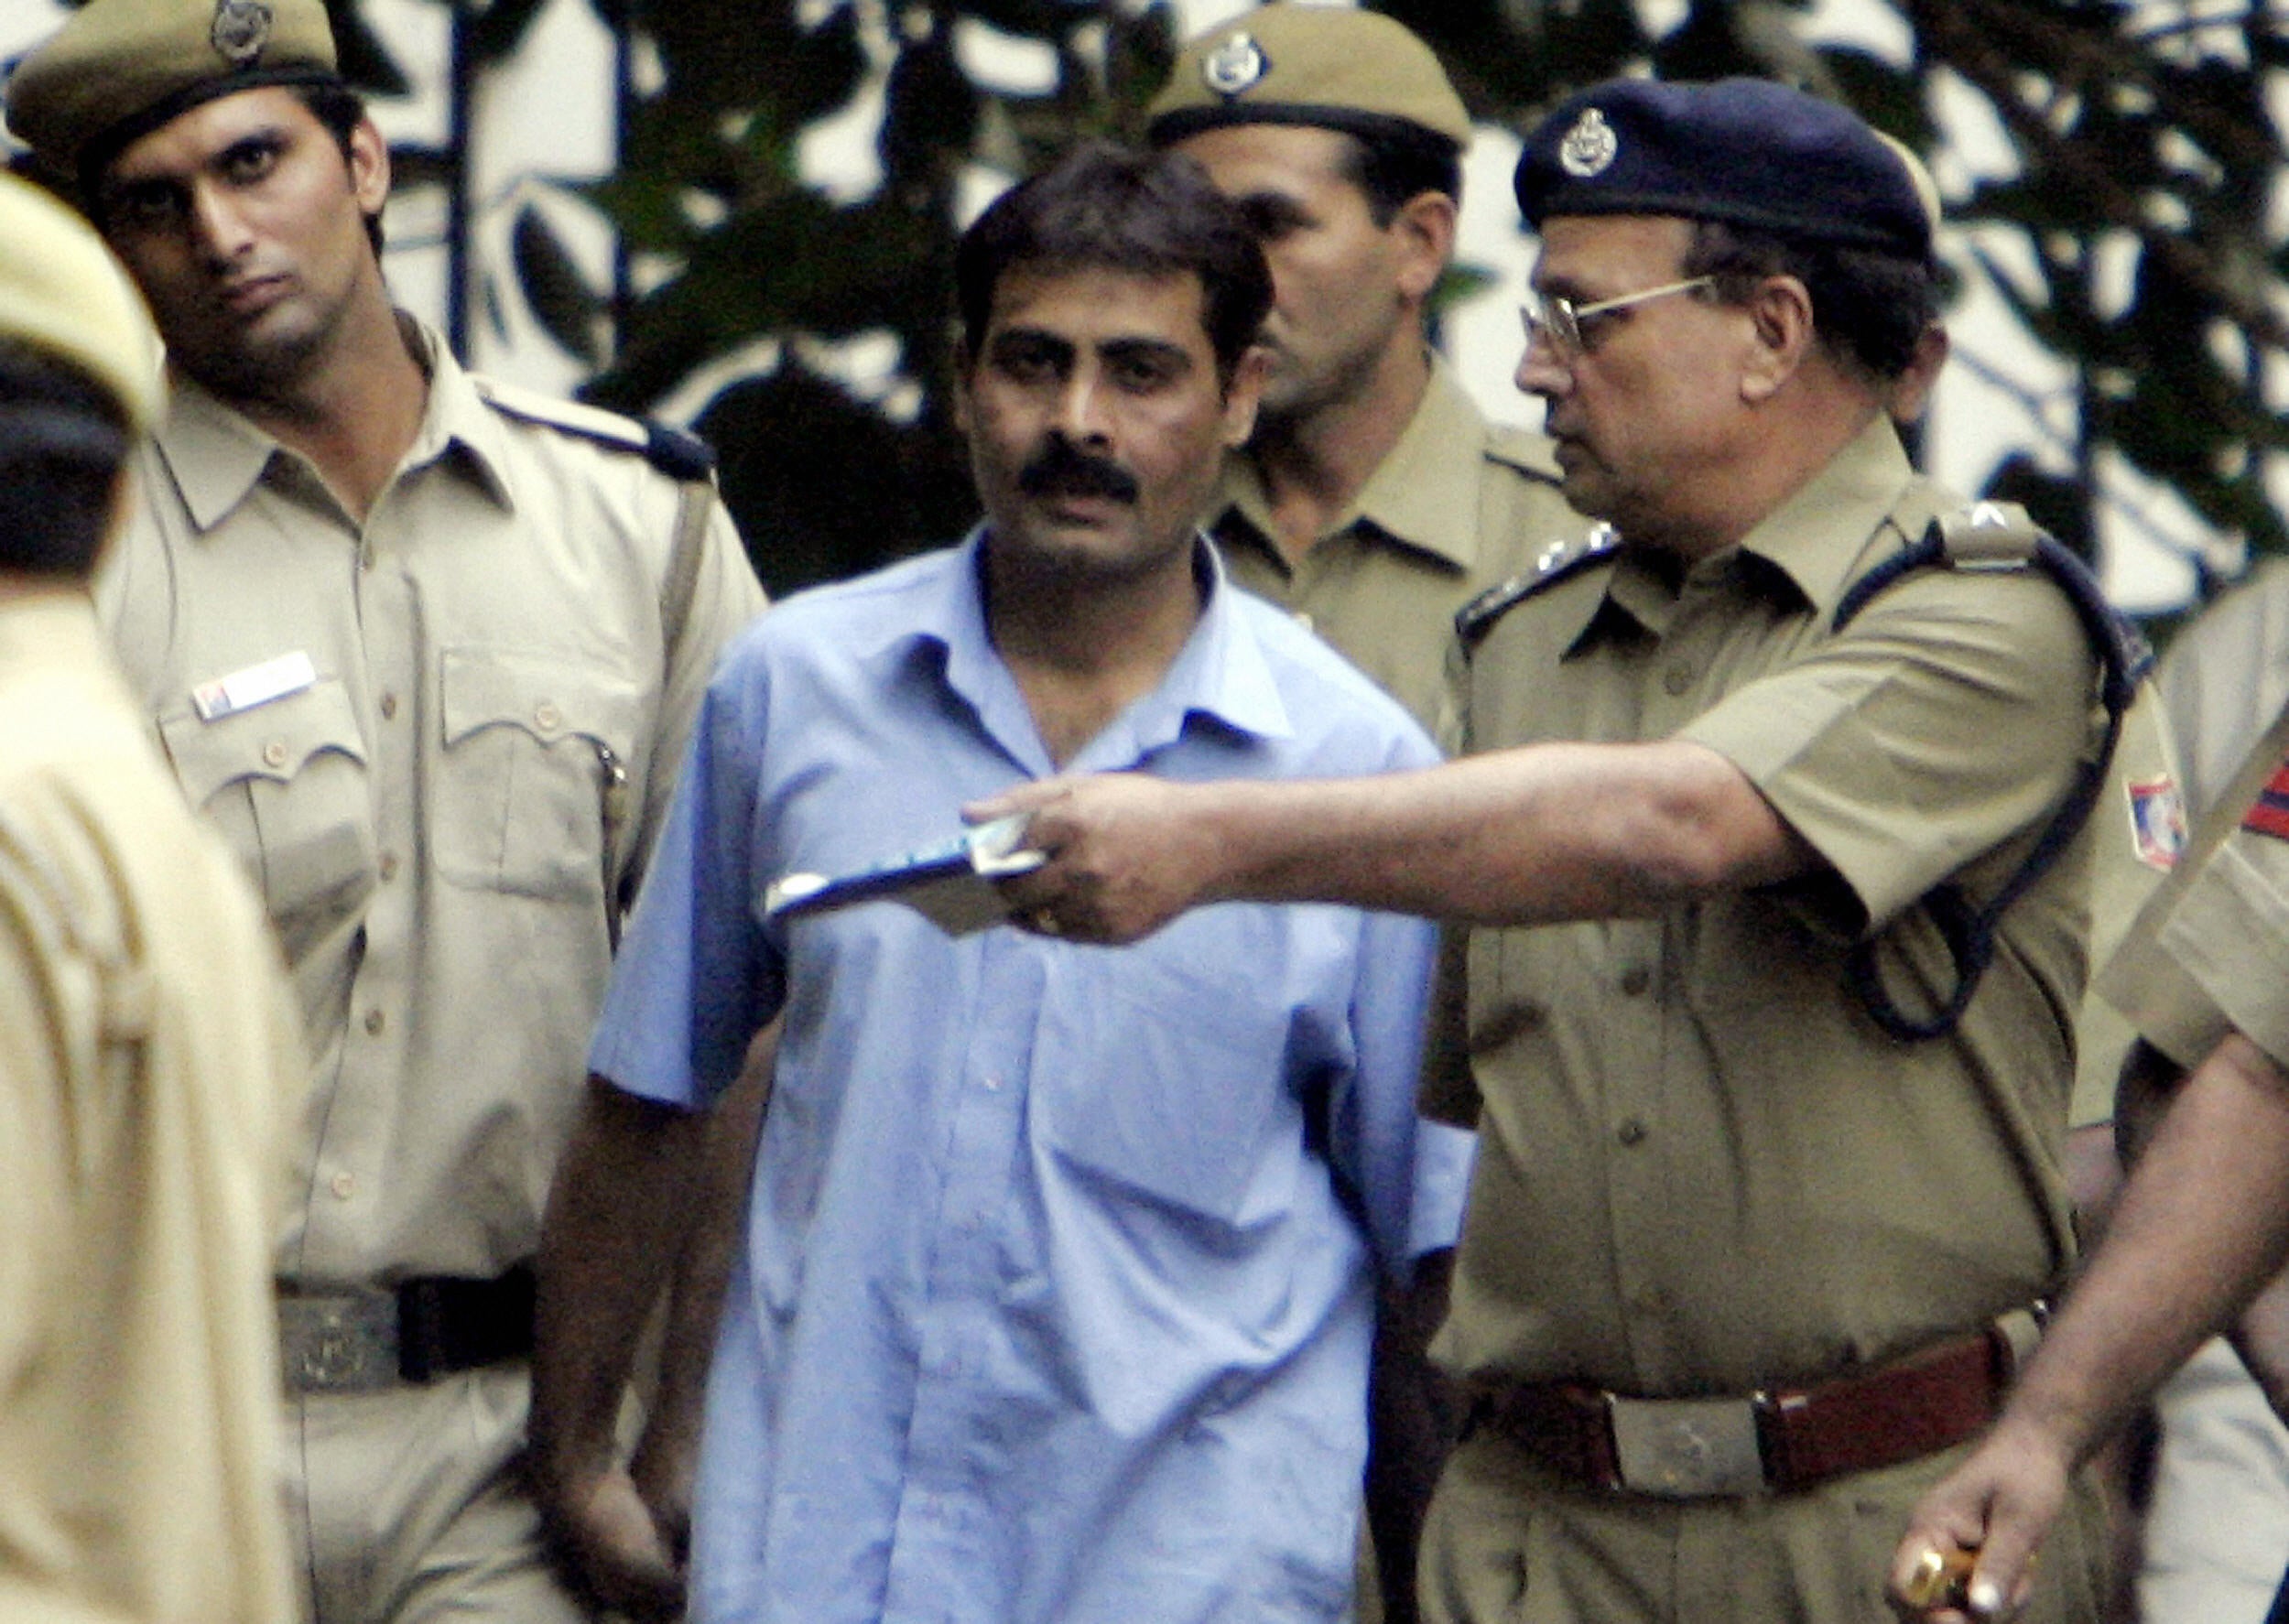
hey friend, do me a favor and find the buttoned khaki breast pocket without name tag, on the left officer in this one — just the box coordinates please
[430,647,639,905]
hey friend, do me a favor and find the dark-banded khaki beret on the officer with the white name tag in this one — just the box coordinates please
[7,0,342,176]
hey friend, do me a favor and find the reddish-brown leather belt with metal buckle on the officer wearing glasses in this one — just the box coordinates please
[1463,1304,2045,1500]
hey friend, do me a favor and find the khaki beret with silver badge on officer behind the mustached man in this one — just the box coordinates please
[1147,2,1470,151]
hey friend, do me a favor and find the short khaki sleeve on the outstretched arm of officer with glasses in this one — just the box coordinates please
[1678,569,2095,933]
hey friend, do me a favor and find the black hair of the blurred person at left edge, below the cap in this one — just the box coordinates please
[0,339,133,581]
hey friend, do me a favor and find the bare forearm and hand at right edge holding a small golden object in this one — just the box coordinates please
[1893,1034,2289,1624]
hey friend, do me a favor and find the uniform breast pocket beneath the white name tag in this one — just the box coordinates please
[158,677,375,951]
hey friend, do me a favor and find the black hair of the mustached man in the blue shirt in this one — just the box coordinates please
[955,142,1273,384]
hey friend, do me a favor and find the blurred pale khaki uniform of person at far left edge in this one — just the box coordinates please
[0,590,305,1624]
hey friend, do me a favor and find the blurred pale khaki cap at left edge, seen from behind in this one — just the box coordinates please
[0,174,160,428]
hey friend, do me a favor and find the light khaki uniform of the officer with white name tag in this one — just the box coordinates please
[99,322,763,1622]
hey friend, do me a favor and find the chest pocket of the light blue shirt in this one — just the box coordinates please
[1035,942,1303,1229]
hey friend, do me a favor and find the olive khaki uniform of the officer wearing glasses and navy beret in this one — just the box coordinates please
[1424,421,2099,1624]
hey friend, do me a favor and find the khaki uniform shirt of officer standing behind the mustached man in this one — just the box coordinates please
[1211,359,1589,748]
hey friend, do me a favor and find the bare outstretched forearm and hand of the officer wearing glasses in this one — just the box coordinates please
[969,742,1817,942]
